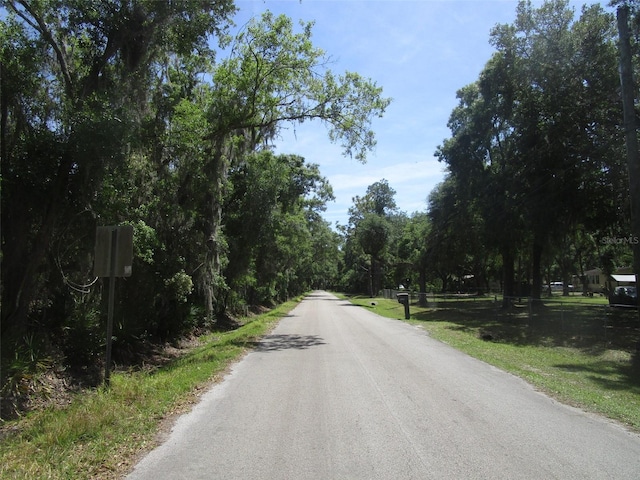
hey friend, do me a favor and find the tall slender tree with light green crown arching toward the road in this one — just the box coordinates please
[196,12,390,322]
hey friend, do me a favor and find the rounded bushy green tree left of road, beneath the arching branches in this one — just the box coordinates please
[223,150,338,305]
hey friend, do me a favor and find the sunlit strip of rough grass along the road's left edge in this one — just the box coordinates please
[0,298,300,480]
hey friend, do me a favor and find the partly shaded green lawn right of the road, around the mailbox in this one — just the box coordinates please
[349,297,640,432]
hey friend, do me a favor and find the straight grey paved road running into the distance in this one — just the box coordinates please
[128,292,640,480]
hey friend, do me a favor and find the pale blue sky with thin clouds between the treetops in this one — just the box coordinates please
[228,0,598,226]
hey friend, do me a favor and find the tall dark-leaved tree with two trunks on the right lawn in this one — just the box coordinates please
[438,1,625,304]
